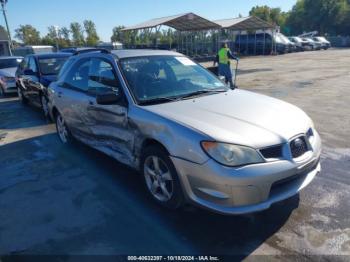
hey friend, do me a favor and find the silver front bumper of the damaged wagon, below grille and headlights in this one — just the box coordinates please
[172,130,321,214]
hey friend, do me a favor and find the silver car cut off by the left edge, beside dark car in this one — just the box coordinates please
[0,56,23,97]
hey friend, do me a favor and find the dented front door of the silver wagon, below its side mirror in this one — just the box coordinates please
[87,58,134,164]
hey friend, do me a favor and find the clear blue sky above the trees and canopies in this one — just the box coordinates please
[0,0,296,41]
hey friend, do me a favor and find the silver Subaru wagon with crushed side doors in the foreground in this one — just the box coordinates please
[49,49,321,214]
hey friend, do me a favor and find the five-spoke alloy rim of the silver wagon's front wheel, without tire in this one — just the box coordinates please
[144,156,174,202]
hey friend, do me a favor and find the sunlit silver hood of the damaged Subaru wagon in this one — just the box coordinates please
[147,90,312,148]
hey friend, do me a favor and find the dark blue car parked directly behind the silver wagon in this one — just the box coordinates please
[16,53,71,117]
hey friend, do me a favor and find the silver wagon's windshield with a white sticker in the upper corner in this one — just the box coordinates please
[120,56,228,105]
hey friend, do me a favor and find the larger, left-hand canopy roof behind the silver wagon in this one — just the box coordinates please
[123,13,221,31]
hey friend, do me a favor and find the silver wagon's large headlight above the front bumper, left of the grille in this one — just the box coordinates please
[201,141,264,167]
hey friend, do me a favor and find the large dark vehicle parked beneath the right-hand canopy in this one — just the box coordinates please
[235,33,290,55]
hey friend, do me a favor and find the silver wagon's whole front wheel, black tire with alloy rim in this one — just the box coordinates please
[140,146,184,209]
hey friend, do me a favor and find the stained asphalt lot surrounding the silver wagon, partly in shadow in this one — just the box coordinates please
[0,49,350,261]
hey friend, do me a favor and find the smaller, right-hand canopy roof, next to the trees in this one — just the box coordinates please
[214,16,276,31]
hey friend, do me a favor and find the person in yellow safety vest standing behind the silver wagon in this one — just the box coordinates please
[214,43,239,88]
